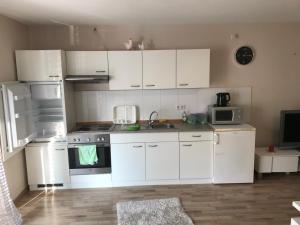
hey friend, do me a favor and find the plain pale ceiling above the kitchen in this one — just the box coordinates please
[0,0,300,25]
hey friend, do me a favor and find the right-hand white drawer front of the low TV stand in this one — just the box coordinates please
[272,156,298,172]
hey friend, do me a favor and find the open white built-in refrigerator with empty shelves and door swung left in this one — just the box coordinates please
[1,81,74,155]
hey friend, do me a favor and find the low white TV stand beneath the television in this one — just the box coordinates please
[255,147,300,177]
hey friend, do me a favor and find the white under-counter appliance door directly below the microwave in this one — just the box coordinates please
[214,131,255,183]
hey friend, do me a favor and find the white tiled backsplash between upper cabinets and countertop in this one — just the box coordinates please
[76,87,251,122]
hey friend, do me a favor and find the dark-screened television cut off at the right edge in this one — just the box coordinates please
[279,110,300,149]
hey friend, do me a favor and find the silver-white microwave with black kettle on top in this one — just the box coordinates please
[208,106,242,124]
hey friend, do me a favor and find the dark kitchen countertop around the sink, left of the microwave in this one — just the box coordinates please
[110,123,213,133]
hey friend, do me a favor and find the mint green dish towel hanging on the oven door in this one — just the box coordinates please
[78,145,98,166]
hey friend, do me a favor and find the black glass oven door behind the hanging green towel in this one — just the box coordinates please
[68,143,111,175]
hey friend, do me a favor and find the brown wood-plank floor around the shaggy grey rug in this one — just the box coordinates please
[17,174,300,225]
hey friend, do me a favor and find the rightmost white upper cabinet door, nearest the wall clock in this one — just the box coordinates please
[177,49,210,88]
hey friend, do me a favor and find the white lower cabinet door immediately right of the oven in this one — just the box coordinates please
[111,143,145,182]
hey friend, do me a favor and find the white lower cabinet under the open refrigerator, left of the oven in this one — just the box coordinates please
[25,143,69,189]
